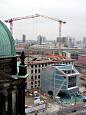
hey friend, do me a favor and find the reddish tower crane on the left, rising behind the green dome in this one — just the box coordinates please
[5,15,39,34]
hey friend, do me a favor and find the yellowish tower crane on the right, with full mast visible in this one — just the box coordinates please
[36,14,66,48]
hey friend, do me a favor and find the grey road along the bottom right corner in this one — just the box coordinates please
[27,103,86,115]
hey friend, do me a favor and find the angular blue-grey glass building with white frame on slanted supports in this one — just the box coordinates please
[41,64,80,97]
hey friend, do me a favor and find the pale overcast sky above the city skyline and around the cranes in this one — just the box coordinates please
[0,0,86,40]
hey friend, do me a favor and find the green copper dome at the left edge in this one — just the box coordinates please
[0,21,16,57]
